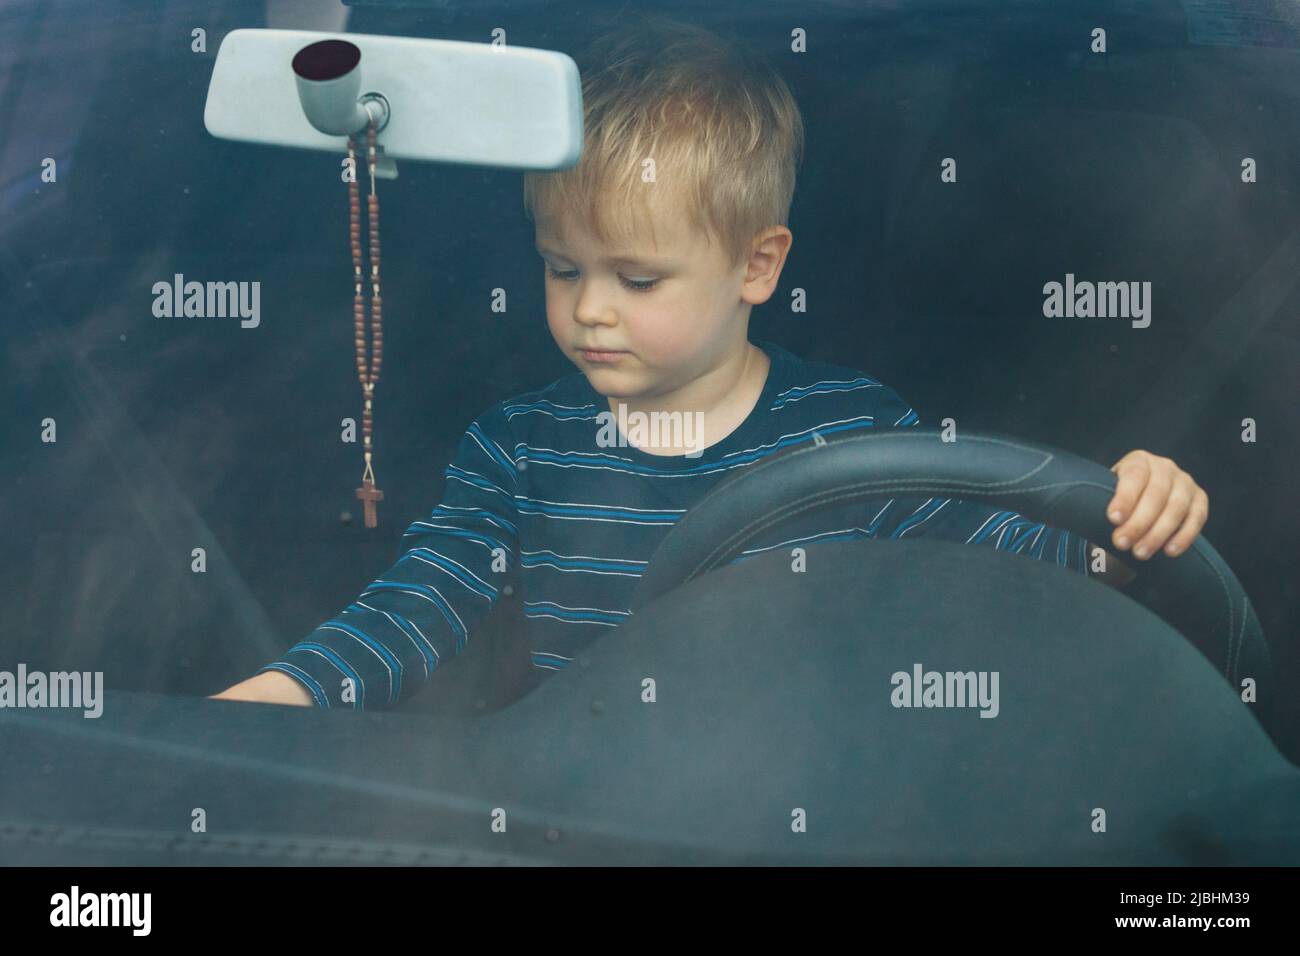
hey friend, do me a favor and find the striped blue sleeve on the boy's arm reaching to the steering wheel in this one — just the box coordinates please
[871,388,1092,575]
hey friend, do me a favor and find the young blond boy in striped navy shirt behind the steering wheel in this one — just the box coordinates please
[217,25,1208,709]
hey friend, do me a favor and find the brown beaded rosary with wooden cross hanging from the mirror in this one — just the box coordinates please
[347,114,384,528]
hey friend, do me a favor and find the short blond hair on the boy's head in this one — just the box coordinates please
[524,17,803,273]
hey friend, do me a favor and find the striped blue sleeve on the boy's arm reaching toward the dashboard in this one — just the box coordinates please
[261,406,517,710]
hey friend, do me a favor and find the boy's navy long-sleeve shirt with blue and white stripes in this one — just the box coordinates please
[263,342,1088,709]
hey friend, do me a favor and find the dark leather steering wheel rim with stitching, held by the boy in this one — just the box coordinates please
[631,428,1274,734]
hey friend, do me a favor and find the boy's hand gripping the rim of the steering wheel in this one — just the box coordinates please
[1106,449,1210,561]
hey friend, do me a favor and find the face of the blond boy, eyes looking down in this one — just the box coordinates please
[536,204,770,401]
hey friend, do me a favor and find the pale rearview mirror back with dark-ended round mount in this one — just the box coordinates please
[203,30,582,178]
